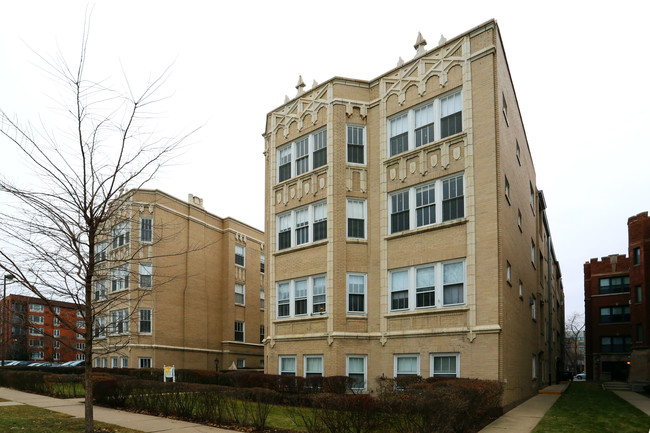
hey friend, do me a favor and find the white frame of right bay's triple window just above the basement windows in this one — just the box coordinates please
[388,257,467,313]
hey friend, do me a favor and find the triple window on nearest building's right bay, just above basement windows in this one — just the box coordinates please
[389,260,465,311]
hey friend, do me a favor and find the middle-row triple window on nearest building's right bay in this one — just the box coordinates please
[389,174,465,233]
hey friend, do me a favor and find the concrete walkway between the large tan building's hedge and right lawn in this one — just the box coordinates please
[480,384,569,433]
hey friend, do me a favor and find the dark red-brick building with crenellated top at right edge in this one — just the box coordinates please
[584,212,650,383]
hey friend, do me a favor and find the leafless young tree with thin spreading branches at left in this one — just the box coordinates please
[0,25,191,433]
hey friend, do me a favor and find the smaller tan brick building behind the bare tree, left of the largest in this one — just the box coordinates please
[93,189,265,370]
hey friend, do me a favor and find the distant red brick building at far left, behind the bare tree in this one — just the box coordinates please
[0,295,84,362]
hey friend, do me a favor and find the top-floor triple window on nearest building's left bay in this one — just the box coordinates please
[277,129,327,182]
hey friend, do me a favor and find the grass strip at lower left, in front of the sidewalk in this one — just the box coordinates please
[0,405,142,433]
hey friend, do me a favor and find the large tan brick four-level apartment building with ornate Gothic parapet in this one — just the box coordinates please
[264,21,564,404]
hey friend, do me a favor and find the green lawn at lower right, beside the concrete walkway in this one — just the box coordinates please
[533,382,650,433]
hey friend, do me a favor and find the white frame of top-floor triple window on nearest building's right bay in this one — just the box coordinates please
[386,88,465,158]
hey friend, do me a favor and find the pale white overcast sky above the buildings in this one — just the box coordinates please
[0,0,650,315]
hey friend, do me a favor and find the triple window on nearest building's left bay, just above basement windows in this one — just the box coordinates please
[277,275,327,318]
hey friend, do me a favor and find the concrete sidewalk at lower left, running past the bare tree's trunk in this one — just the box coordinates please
[0,387,233,433]
